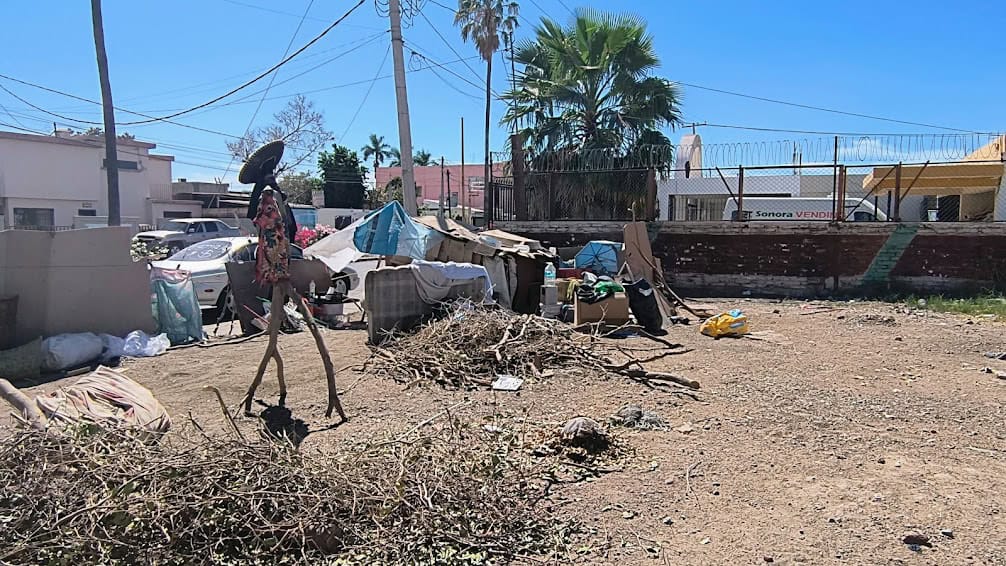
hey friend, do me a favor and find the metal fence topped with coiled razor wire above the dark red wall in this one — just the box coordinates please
[487,157,1006,228]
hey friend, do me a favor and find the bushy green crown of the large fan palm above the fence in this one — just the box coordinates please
[503,9,681,150]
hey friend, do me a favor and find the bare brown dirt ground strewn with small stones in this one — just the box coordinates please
[5,300,1006,564]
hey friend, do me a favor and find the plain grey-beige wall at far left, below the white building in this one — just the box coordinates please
[0,226,154,343]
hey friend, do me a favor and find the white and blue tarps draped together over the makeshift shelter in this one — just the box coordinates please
[304,201,444,272]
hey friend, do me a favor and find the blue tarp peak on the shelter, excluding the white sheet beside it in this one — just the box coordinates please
[353,201,444,259]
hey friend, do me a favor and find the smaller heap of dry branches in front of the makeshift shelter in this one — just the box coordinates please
[373,301,698,389]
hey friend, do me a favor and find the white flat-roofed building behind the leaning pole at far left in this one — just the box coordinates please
[0,132,202,229]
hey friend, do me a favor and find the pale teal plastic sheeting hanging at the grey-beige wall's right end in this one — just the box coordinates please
[150,267,203,345]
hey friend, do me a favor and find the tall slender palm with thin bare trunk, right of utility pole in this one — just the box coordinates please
[454,0,519,219]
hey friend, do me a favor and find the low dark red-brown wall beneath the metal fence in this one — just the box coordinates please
[497,222,1006,297]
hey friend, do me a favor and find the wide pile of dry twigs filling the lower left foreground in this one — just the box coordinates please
[0,425,568,564]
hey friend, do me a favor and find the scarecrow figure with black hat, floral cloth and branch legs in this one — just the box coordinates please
[237,140,346,420]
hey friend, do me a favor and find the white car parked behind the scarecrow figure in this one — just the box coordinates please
[153,236,360,315]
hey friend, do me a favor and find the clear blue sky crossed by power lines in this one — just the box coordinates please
[0,0,1006,182]
